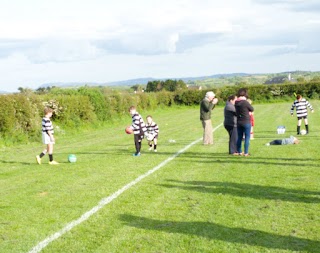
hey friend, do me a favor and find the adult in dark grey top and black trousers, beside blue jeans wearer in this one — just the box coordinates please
[223,95,238,154]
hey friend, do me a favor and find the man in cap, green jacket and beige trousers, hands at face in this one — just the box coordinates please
[200,91,218,145]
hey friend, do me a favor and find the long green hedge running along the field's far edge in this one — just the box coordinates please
[0,82,320,145]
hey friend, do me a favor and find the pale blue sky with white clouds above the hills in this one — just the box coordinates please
[0,0,320,91]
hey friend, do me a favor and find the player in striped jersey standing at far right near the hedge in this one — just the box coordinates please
[290,94,313,135]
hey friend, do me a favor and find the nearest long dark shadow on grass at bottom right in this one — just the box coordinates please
[119,214,320,252]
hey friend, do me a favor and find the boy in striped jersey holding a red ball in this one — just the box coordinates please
[129,106,147,156]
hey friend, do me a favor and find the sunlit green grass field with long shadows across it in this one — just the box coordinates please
[0,101,320,253]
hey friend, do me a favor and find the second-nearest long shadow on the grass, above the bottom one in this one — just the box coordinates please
[160,180,320,203]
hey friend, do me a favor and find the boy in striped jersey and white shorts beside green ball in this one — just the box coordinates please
[36,107,59,165]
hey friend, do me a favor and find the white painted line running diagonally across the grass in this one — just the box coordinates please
[29,123,222,253]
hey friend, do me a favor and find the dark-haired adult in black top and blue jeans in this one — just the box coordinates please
[235,88,254,156]
